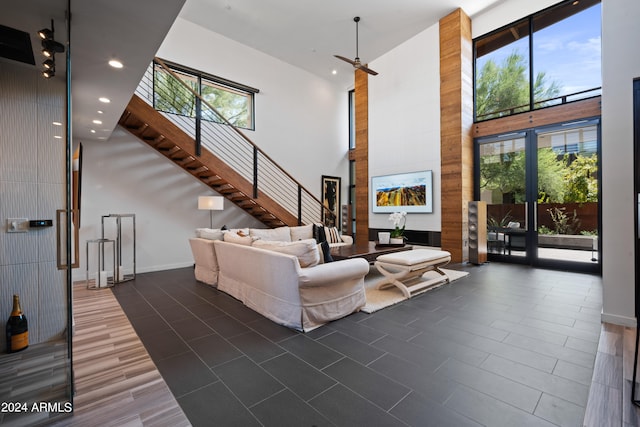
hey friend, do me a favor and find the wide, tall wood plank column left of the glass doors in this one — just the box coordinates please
[440,9,473,262]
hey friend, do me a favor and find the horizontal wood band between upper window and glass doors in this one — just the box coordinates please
[473,96,602,138]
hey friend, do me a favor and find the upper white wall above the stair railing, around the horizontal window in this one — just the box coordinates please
[157,18,349,202]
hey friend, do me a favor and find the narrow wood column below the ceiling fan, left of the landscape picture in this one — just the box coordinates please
[354,70,369,245]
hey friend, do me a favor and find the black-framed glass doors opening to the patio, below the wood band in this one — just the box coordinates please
[476,120,600,272]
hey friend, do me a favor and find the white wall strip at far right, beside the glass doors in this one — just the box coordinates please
[601,0,640,326]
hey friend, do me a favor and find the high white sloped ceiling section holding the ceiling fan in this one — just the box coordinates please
[180,0,506,87]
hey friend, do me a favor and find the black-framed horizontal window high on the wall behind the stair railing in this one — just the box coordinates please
[154,60,258,130]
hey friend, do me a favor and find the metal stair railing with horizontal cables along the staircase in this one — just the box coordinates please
[135,58,338,231]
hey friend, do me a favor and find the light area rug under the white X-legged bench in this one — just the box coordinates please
[361,266,469,313]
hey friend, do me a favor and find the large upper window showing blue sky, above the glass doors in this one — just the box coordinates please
[474,0,602,121]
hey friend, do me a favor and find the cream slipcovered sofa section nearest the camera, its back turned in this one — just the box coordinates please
[214,240,369,332]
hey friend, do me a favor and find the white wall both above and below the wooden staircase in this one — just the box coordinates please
[74,18,348,280]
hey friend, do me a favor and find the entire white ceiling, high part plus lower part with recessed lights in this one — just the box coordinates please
[0,0,506,141]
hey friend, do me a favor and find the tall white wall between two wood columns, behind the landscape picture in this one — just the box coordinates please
[369,24,441,231]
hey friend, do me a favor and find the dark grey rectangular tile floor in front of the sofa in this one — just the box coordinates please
[114,263,602,427]
